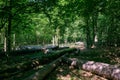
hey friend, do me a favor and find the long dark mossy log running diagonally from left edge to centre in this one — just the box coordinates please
[0,48,76,78]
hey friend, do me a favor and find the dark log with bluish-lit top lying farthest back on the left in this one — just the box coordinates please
[0,45,59,57]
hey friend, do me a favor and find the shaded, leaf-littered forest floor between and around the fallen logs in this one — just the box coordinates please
[0,48,120,80]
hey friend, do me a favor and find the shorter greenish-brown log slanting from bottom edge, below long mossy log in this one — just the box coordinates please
[24,54,66,80]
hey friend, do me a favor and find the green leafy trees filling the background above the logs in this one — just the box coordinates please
[0,0,120,56]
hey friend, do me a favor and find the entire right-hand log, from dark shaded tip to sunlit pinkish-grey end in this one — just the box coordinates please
[62,57,120,80]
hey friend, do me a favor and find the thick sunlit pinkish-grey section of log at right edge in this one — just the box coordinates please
[82,61,120,80]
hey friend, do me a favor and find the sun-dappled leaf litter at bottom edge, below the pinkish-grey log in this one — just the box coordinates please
[45,64,107,80]
